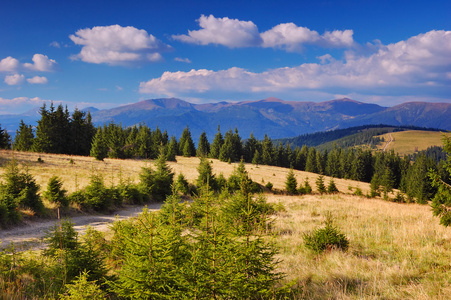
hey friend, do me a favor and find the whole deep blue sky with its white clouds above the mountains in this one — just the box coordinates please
[0,0,451,114]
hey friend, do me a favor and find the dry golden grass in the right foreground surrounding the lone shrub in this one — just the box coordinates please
[268,195,451,299]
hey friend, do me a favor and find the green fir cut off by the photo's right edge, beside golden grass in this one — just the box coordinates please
[429,135,451,227]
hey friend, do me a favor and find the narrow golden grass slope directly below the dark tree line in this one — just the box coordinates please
[0,150,370,194]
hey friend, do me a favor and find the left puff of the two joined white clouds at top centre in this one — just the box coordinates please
[172,15,262,48]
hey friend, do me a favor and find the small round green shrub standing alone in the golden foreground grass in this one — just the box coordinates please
[304,214,349,254]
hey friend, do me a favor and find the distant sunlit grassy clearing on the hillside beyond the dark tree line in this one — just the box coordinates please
[378,130,443,155]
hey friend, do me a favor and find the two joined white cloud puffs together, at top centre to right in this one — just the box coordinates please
[172,15,354,51]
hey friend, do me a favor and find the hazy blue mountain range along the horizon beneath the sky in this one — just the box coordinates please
[0,98,451,142]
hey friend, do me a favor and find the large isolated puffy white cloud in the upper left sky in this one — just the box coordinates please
[69,25,171,65]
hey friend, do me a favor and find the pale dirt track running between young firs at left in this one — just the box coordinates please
[0,204,161,251]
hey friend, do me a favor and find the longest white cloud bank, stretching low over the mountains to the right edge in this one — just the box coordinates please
[139,31,451,102]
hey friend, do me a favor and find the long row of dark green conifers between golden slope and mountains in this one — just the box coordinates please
[0,104,450,203]
